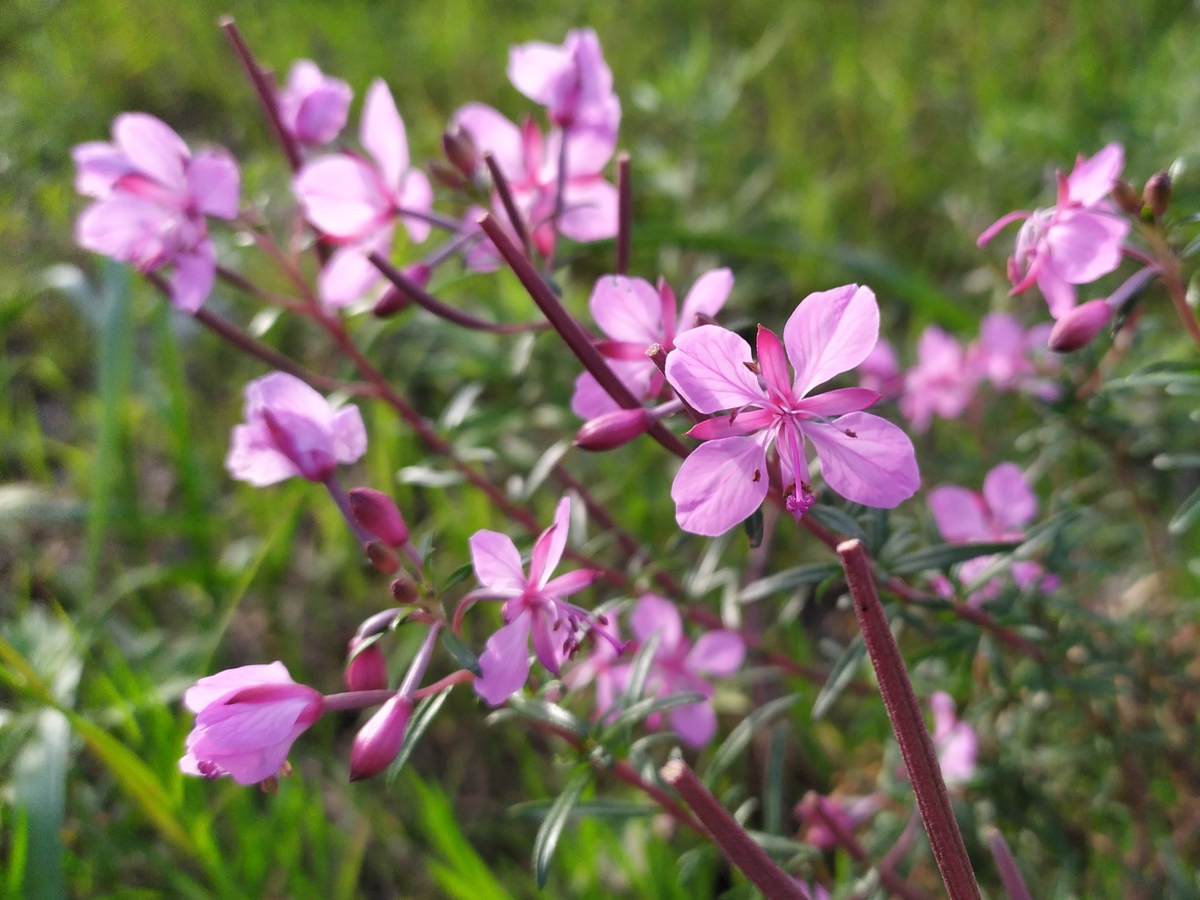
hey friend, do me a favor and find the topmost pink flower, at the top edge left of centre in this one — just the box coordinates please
[509,29,620,156]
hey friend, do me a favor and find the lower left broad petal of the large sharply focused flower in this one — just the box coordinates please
[671,434,768,538]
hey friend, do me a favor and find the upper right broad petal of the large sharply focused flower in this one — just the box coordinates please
[784,284,880,397]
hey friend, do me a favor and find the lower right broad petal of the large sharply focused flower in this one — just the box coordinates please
[804,412,920,509]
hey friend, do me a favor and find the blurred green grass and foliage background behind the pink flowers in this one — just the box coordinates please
[0,0,1200,900]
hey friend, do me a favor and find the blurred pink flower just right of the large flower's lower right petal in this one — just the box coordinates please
[929,462,1058,606]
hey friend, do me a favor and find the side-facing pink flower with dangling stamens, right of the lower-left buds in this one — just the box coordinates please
[468,497,607,706]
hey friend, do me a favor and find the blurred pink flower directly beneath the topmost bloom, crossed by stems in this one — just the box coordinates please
[454,103,617,271]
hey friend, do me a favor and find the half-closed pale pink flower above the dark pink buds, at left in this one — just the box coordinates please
[226,372,367,487]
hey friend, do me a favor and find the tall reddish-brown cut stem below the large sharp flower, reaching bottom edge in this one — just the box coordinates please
[838,540,979,900]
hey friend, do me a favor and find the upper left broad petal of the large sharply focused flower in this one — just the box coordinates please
[666,325,766,415]
